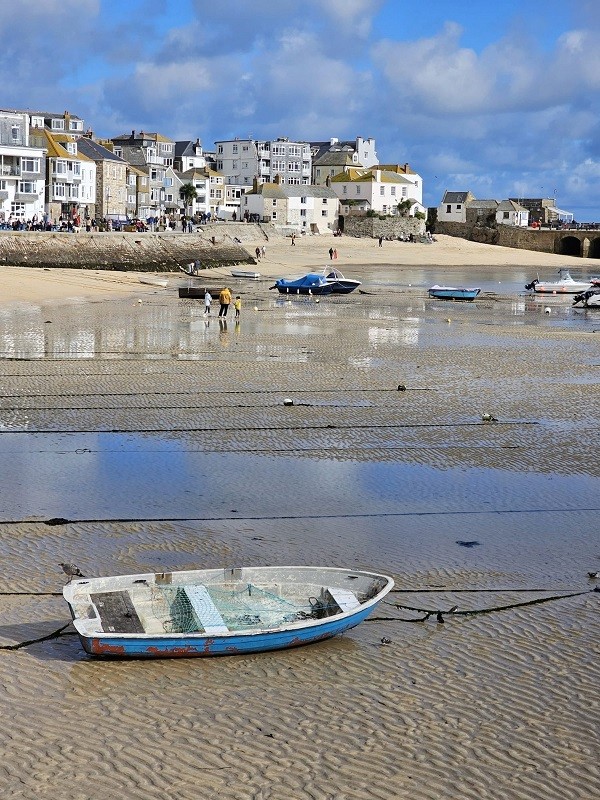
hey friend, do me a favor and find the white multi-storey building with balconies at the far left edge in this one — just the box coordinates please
[0,111,46,223]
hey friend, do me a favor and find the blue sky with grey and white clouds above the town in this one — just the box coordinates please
[0,0,600,221]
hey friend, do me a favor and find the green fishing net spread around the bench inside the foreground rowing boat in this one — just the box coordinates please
[152,584,322,633]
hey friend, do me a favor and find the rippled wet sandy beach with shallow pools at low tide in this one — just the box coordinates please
[0,236,600,800]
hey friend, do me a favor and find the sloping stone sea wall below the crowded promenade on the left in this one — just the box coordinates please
[0,223,270,272]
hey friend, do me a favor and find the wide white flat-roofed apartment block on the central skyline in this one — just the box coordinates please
[215,138,312,187]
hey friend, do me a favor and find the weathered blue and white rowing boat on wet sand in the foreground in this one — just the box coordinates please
[63,567,394,658]
